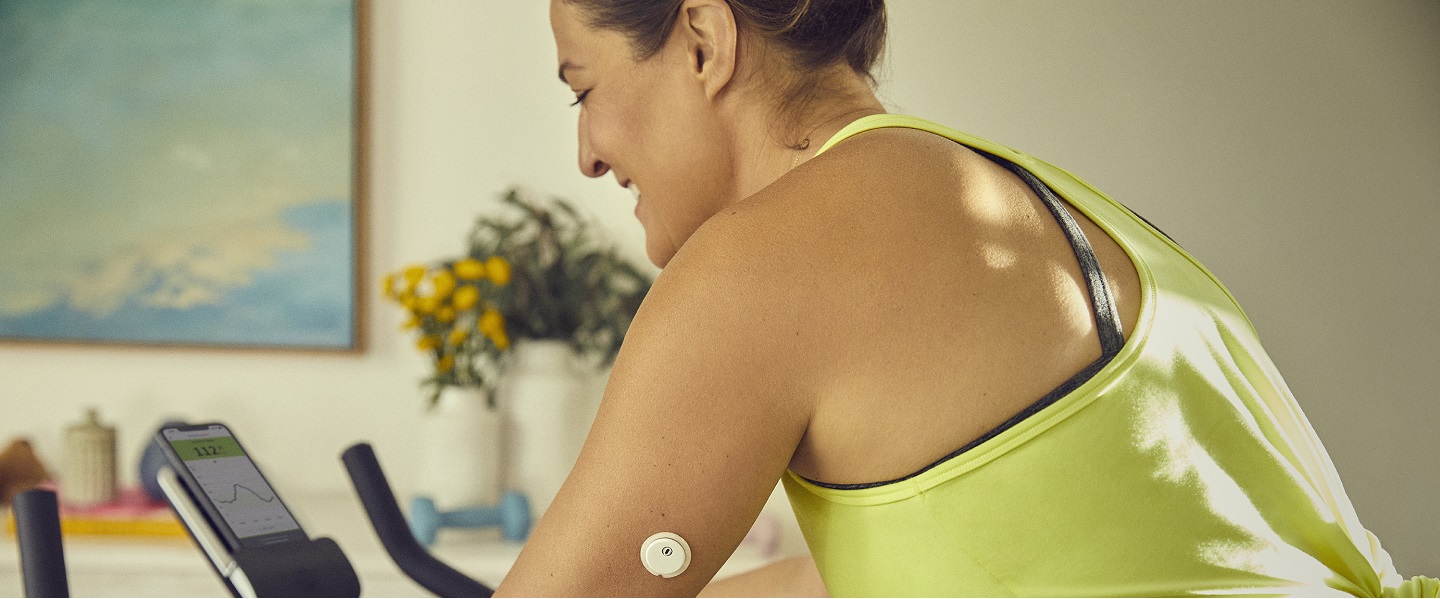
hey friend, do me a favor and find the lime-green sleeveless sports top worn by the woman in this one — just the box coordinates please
[783,114,1440,596]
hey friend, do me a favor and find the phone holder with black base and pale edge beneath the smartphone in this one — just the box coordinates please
[156,467,360,598]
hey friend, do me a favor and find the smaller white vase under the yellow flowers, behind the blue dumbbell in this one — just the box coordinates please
[419,387,503,510]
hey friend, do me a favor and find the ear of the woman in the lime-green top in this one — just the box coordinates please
[675,0,740,99]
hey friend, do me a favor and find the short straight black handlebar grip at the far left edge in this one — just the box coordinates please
[14,490,71,598]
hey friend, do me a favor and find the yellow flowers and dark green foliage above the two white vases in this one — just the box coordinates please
[382,189,651,407]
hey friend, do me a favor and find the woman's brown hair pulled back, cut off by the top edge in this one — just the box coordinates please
[567,0,886,83]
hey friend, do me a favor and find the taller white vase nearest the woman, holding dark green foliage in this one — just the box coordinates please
[498,340,595,518]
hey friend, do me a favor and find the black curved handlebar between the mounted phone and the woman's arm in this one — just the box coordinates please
[340,443,494,598]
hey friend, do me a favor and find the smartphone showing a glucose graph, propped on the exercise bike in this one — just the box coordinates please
[156,422,308,553]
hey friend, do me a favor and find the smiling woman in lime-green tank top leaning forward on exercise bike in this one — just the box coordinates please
[500,0,1437,596]
